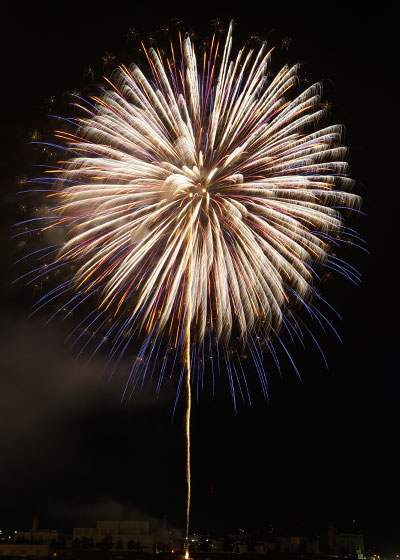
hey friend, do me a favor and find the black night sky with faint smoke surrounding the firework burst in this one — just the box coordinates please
[0,2,400,553]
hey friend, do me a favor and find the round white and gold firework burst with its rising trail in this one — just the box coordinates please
[18,20,359,548]
